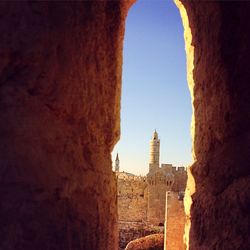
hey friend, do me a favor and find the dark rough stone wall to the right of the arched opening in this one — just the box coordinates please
[179,1,250,250]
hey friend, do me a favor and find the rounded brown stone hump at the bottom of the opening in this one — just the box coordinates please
[125,234,164,250]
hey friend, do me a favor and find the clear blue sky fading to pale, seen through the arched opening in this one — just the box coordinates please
[112,0,192,175]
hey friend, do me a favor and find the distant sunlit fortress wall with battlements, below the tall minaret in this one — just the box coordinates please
[118,168,187,226]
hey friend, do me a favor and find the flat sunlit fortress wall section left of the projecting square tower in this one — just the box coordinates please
[117,177,148,221]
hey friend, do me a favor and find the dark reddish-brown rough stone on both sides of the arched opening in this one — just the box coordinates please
[0,0,250,250]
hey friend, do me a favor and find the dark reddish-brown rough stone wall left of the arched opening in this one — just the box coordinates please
[0,1,134,250]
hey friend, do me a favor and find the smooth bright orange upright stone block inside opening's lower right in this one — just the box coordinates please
[165,192,185,250]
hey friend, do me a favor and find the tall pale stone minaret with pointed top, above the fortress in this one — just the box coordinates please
[149,130,160,172]
